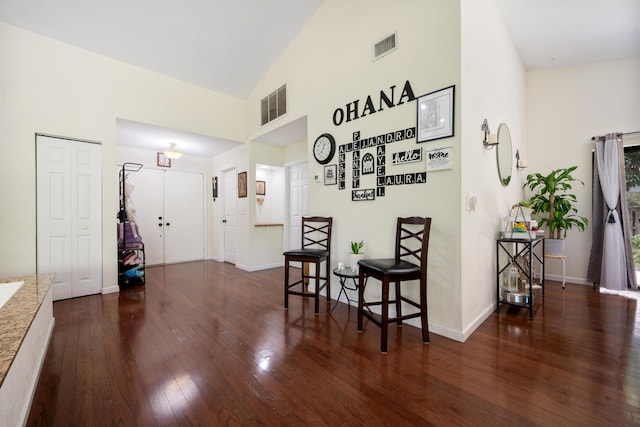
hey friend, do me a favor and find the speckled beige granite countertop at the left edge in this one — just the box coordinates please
[0,273,55,386]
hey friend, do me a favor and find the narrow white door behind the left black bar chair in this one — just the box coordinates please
[287,163,309,249]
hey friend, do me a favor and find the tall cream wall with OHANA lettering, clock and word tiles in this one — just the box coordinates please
[248,0,461,335]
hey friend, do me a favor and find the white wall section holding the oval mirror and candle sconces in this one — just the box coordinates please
[459,0,527,338]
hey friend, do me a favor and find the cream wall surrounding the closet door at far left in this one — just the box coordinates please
[0,23,246,289]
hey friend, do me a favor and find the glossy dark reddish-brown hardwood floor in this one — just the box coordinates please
[27,261,640,426]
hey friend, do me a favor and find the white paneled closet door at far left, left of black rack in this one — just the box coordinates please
[36,135,102,300]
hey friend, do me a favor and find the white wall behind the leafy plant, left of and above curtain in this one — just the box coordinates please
[526,58,640,283]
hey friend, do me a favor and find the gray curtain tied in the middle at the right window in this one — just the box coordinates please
[587,134,637,290]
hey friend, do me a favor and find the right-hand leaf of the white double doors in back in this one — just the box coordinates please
[164,171,205,263]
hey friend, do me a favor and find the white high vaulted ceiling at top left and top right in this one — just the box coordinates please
[0,0,640,156]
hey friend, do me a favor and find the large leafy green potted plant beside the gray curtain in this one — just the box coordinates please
[522,166,589,255]
